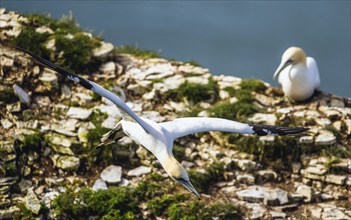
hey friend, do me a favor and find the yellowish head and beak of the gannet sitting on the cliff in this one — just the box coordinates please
[273,47,306,79]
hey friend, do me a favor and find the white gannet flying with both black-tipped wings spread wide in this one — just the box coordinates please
[18,48,308,197]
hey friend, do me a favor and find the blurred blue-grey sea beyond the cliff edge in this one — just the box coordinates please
[1,0,351,97]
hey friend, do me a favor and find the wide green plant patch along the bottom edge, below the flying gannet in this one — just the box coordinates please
[53,172,242,219]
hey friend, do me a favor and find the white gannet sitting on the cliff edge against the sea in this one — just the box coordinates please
[273,47,320,101]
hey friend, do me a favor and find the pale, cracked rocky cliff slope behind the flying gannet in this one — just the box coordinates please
[0,9,351,219]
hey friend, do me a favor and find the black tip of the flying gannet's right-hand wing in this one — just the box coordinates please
[250,125,309,136]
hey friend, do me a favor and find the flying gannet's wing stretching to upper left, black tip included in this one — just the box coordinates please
[16,46,156,135]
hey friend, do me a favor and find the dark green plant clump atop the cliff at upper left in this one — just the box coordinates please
[13,14,101,73]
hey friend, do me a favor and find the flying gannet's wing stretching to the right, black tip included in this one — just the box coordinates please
[160,117,308,139]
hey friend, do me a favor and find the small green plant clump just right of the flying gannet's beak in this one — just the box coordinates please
[189,163,225,192]
